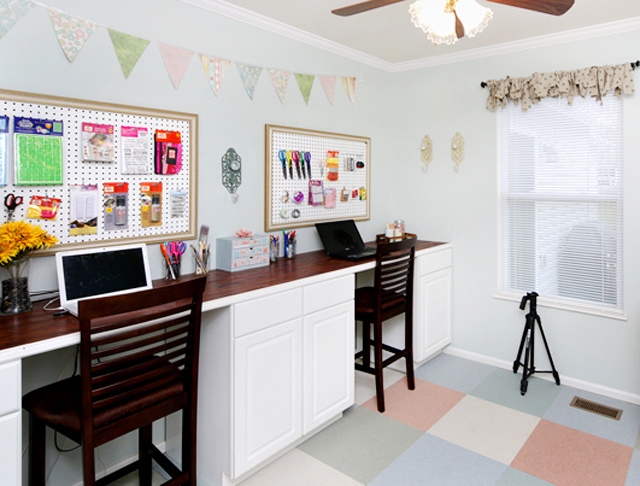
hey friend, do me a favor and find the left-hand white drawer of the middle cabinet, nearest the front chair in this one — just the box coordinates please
[234,289,302,337]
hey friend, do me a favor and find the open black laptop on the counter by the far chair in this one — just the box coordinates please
[316,219,376,260]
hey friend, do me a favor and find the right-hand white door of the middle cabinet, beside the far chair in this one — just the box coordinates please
[303,301,355,434]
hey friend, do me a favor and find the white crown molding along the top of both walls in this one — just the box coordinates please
[182,0,640,73]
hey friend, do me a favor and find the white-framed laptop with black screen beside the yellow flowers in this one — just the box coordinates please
[56,244,153,316]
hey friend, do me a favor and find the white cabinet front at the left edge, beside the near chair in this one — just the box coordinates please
[0,360,22,485]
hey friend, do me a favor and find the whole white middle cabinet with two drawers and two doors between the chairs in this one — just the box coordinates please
[228,275,354,480]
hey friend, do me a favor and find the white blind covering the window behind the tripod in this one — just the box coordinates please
[499,95,623,314]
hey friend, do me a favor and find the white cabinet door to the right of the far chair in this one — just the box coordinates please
[414,268,451,362]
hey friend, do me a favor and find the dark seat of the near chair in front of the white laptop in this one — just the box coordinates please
[22,360,184,440]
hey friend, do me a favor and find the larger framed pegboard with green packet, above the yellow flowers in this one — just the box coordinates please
[0,90,198,254]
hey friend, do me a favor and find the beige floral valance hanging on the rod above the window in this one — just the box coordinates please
[482,63,634,111]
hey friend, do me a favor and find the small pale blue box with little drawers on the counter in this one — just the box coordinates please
[216,235,269,272]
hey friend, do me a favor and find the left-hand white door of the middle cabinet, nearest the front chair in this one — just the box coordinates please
[234,318,302,477]
